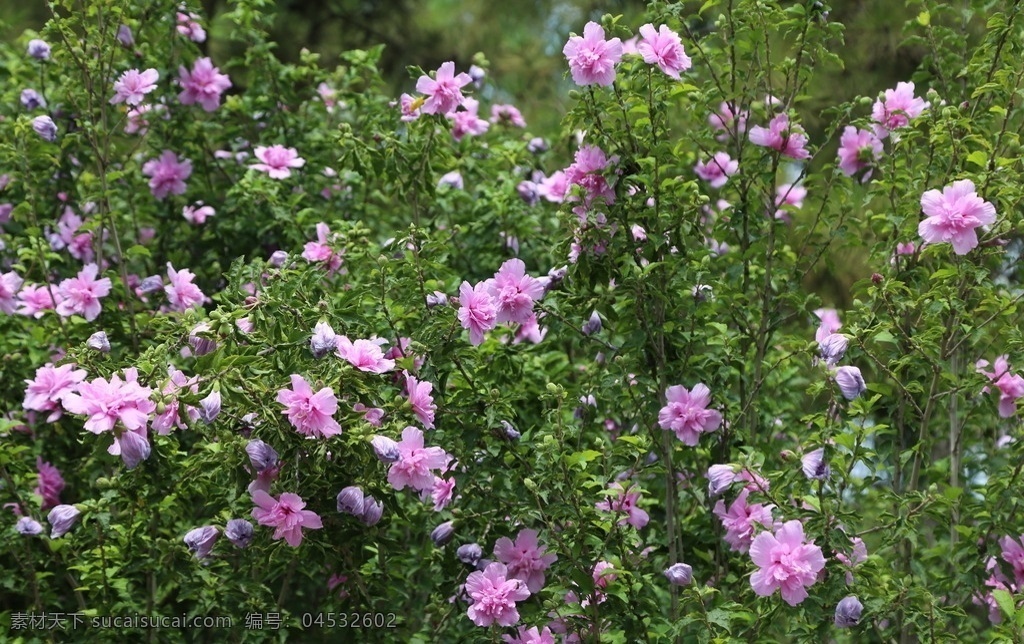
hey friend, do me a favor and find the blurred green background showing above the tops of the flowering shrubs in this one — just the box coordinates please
[0,0,921,136]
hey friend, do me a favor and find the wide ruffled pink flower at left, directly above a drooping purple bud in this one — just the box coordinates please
[60,368,157,432]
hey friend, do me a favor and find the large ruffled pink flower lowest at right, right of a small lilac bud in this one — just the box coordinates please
[751,521,825,606]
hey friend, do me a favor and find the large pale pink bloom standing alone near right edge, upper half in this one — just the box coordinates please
[918,179,995,255]
